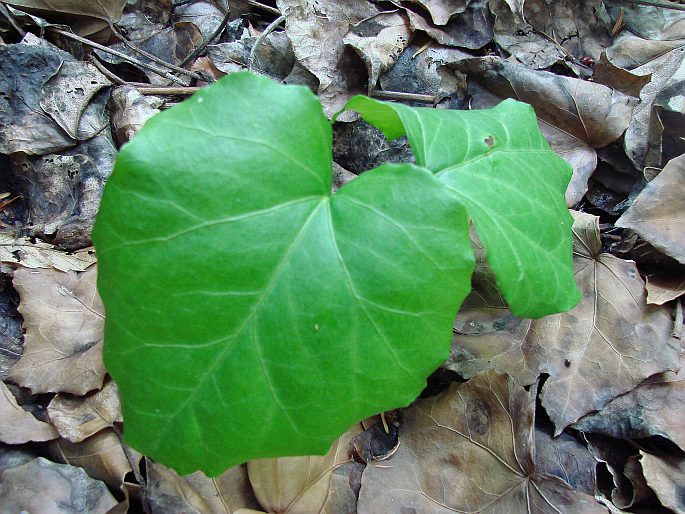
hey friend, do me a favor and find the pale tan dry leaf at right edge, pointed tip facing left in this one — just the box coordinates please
[616,154,685,264]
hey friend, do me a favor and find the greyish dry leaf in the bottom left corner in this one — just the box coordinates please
[0,457,117,514]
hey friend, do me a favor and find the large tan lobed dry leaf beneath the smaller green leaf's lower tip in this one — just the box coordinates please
[452,213,680,434]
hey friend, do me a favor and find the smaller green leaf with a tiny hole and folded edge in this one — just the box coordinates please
[345,96,580,318]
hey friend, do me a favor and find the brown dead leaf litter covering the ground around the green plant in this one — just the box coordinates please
[0,0,685,513]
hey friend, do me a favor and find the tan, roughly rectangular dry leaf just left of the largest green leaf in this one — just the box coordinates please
[10,266,105,395]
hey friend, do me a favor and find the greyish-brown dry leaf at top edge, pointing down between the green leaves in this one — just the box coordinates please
[276,0,380,116]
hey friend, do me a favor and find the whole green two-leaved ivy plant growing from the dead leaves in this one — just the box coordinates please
[93,73,579,475]
